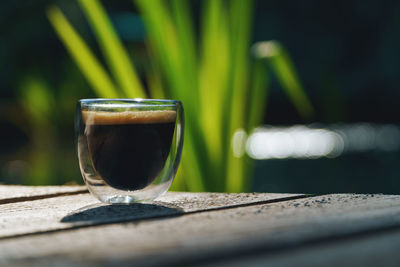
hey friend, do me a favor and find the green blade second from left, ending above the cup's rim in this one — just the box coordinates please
[78,0,146,98]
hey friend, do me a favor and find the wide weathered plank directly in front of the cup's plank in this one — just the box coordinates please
[0,195,400,266]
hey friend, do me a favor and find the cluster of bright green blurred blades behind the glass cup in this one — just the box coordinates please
[47,0,312,192]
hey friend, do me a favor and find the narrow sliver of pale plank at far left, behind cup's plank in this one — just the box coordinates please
[0,185,87,204]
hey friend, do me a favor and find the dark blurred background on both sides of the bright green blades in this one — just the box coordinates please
[0,0,400,193]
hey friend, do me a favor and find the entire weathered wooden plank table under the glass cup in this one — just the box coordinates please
[0,186,400,266]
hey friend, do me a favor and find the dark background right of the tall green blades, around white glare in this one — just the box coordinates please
[254,0,400,194]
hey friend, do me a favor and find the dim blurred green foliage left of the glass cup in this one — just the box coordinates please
[11,72,85,185]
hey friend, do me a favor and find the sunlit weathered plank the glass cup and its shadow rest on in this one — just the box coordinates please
[0,192,304,239]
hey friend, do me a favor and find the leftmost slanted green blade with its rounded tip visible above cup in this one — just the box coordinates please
[47,6,119,98]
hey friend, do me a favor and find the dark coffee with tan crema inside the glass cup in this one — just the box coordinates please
[82,111,176,190]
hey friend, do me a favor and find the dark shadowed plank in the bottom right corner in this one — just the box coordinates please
[209,229,400,267]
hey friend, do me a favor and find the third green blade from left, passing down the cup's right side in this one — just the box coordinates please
[134,0,208,193]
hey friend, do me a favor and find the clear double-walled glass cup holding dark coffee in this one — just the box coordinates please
[75,99,184,204]
